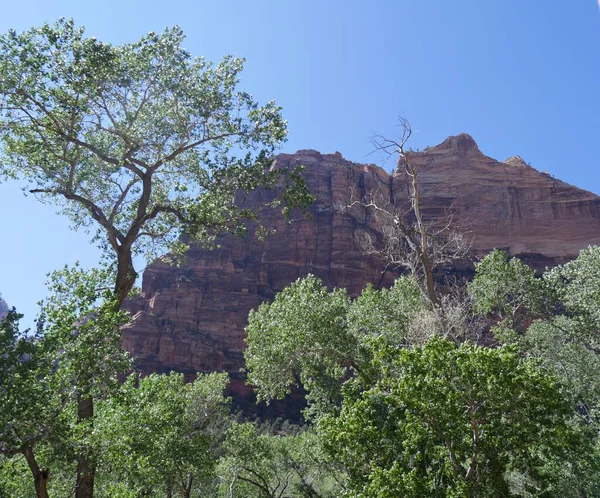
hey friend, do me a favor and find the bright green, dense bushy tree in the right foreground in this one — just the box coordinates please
[319,338,590,497]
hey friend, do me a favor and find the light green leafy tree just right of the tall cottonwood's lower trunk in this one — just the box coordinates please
[95,373,228,497]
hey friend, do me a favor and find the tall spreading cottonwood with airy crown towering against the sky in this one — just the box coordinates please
[0,20,311,497]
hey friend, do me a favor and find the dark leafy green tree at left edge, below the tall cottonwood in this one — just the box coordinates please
[0,267,129,498]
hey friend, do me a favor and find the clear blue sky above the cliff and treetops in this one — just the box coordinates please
[0,0,600,324]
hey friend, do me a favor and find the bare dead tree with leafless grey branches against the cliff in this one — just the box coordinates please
[346,117,471,332]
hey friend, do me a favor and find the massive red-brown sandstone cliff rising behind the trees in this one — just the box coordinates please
[124,134,600,414]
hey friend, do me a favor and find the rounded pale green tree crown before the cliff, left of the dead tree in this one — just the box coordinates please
[245,275,358,418]
